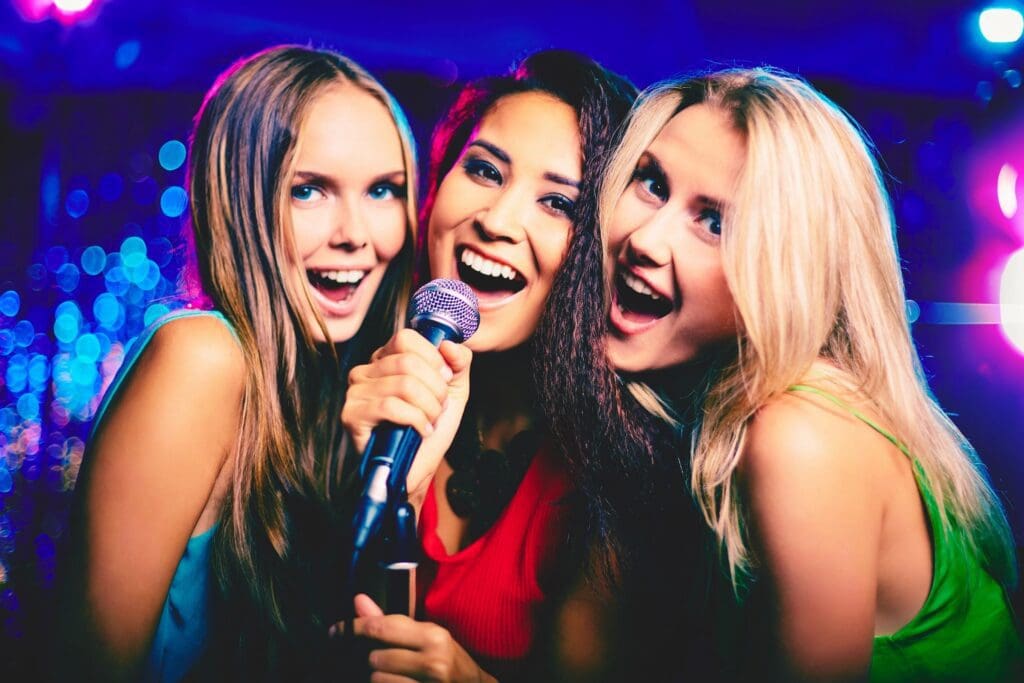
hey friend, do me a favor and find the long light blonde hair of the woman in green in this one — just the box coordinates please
[601,69,1016,586]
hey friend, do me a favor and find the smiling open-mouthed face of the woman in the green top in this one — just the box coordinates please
[608,104,745,373]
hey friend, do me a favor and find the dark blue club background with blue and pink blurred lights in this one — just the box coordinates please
[0,0,1024,680]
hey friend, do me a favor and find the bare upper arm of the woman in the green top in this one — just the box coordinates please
[739,394,883,680]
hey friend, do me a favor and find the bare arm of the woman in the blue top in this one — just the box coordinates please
[62,317,244,680]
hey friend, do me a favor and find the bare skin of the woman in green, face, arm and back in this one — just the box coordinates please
[608,104,932,680]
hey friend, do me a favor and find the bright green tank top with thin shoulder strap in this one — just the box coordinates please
[790,384,1024,683]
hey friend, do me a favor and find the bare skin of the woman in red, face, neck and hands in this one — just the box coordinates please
[342,93,582,682]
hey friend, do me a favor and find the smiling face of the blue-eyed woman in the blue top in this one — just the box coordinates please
[289,83,408,343]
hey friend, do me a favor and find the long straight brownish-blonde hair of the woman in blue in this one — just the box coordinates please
[184,46,417,643]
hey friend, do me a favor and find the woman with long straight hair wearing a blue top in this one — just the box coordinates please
[65,46,417,681]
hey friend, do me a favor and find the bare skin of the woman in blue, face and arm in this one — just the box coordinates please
[66,85,406,681]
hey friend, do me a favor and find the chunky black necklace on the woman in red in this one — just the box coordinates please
[444,413,541,535]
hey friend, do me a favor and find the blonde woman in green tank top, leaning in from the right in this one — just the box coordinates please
[601,69,1022,681]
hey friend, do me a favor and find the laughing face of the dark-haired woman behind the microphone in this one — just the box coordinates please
[427,92,583,351]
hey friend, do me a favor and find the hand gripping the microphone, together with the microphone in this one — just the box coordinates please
[342,280,479,551]
